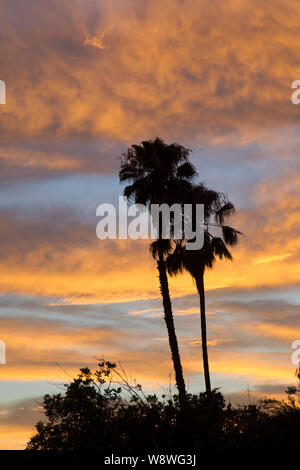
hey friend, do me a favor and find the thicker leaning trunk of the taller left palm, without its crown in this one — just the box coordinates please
[157,253,186,408]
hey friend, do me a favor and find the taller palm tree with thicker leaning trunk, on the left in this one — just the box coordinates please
[119,138,196,407]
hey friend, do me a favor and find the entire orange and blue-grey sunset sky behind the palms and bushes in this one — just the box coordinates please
[0,0,300,449]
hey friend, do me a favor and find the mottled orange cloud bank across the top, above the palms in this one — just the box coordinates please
[1,0,300,144]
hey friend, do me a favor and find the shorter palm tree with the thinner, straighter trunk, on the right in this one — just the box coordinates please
[166,184,241,395]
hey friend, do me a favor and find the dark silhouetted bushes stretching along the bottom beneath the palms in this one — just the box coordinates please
[27,361,300,455]
